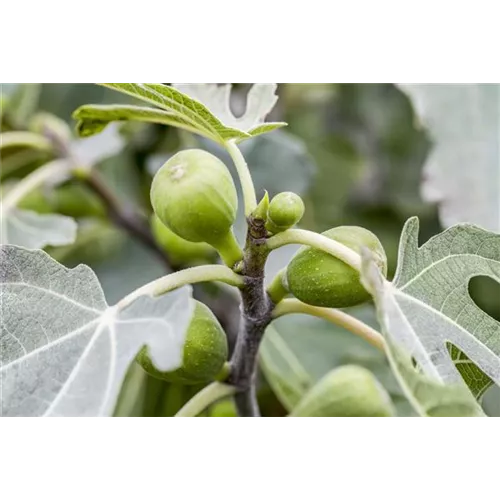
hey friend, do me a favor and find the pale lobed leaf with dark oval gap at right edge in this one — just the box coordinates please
[363,218,500,416]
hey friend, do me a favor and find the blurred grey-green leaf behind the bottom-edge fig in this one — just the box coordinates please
[260,306,413,416]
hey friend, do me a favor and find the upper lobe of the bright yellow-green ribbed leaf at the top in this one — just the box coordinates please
[91,82,249,144]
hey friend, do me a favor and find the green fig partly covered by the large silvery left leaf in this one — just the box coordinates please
[137,299,228,385]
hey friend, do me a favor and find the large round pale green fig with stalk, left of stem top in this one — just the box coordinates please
[151,149,242,267]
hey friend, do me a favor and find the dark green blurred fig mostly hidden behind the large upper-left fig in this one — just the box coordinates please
[150,214,216,266]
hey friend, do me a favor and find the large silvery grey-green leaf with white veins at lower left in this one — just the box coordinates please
[0,245,192,421]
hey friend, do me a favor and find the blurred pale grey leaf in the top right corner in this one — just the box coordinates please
[398,80,500,232]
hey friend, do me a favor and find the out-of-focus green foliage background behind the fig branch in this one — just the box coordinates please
[0,82,500,418]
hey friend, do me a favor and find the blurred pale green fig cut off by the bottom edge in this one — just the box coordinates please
[289,365,395,418]
